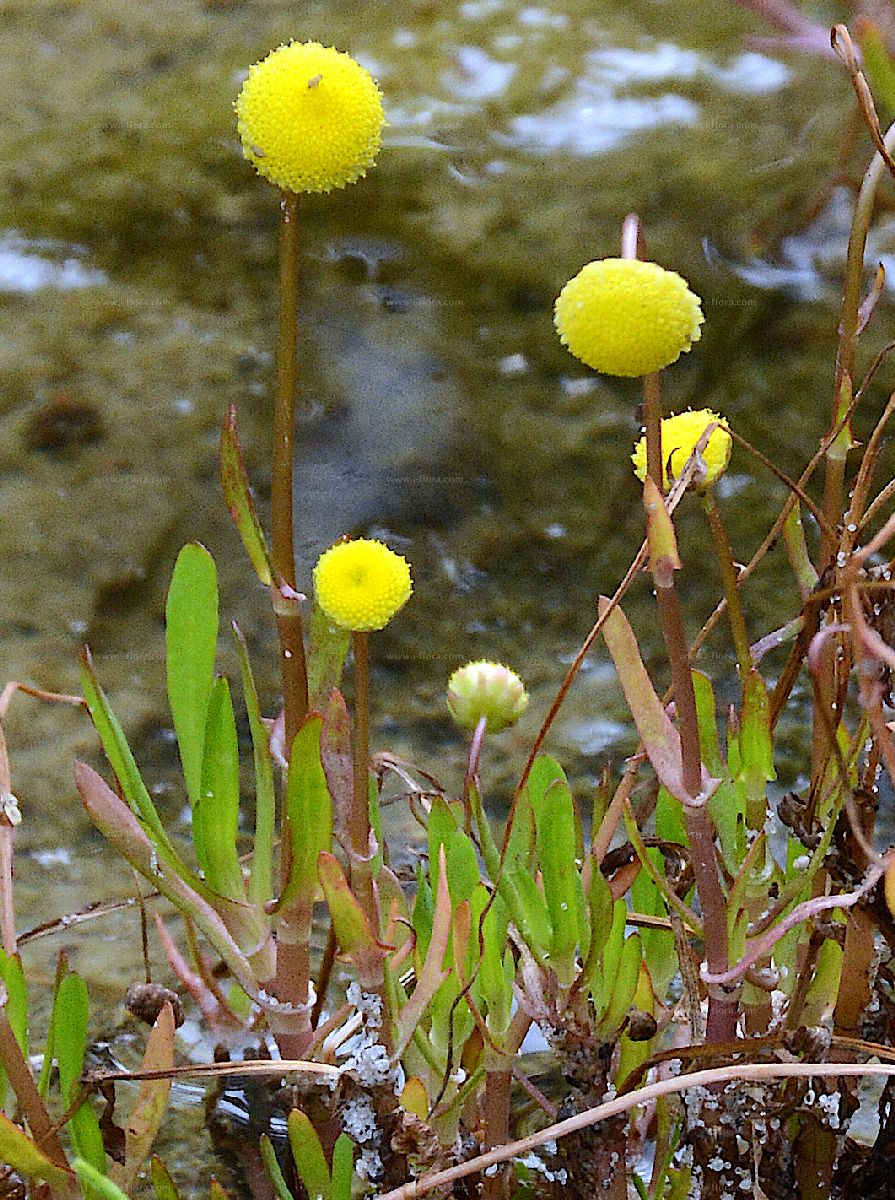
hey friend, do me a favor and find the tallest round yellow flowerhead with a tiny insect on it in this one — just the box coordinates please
[235,42,385,192]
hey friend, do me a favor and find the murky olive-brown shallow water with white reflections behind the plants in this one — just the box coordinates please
[0,0,895,1190]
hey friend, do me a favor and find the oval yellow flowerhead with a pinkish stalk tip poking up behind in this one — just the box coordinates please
[553,258,704,376]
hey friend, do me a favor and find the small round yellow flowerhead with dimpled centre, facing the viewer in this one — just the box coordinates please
[314,538,413,634]
